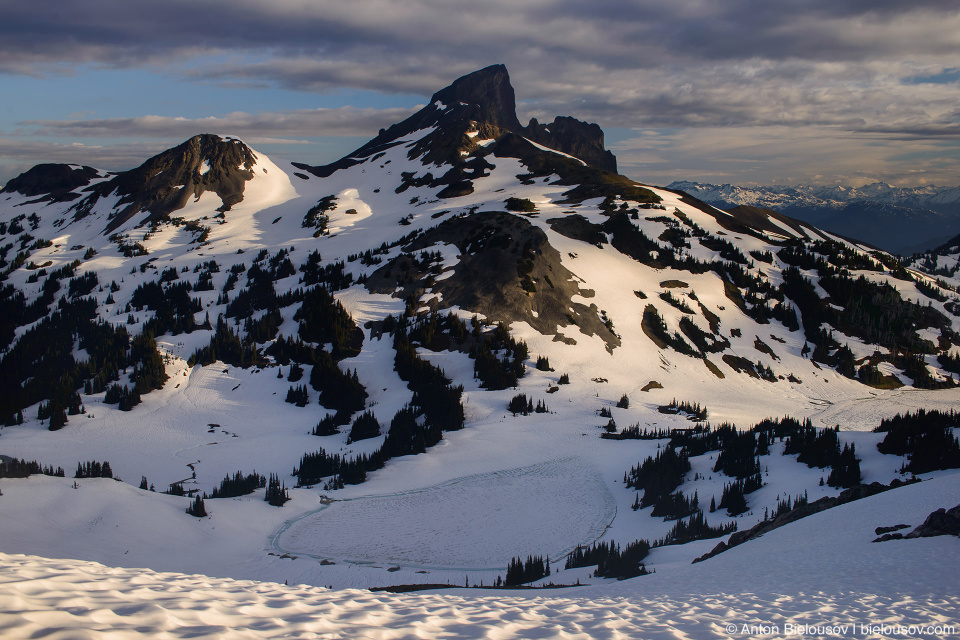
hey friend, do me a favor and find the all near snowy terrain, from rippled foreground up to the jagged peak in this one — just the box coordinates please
[0,66,960,638]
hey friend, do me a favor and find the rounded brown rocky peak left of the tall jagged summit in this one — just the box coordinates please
[74,133,256,231]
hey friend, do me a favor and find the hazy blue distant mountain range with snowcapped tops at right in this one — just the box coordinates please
[667,180,960,255]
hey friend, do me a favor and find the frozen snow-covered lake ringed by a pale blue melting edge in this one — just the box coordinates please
[273,458,617,571]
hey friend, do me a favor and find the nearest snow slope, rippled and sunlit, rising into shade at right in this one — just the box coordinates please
[0,474,960,639]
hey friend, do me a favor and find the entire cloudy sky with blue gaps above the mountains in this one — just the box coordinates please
[0,0,960,186]
